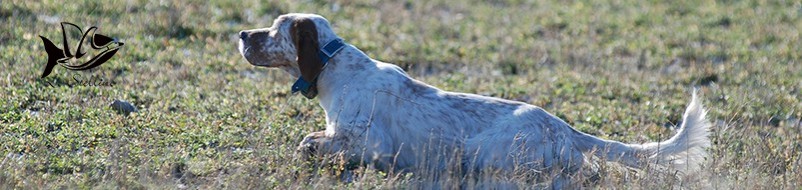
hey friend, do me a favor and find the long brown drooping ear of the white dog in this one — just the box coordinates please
[290,18,323,82]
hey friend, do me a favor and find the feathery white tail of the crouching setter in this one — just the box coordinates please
[576,91,710,173]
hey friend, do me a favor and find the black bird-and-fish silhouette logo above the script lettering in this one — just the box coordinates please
[39,22,124,78]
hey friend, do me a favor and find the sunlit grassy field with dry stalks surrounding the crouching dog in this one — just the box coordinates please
[0,0,802,189]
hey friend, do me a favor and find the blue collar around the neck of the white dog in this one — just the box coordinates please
[292,38,345,99]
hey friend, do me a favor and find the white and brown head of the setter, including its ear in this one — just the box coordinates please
[239,13,336,81]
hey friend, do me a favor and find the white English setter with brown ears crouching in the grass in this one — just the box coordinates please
[239,13,710,188]
